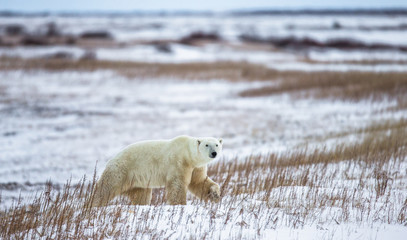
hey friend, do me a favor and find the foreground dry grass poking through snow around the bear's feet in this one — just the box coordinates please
[0,120,407,239]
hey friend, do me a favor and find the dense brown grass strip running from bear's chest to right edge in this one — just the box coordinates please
[209,119,407,176]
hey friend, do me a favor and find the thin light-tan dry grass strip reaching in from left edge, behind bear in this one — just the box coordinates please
[0,57,277,81]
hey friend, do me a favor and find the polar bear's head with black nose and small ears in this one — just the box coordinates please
[197,137,223,165]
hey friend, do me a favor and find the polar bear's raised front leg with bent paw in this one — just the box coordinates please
[188,166,220,202]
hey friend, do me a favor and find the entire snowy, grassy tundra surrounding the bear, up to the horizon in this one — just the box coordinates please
[0,11,407,240]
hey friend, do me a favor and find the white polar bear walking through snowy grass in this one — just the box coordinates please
[91,136,222,206]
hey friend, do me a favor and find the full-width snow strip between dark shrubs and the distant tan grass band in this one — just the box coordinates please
[0,44,407,72]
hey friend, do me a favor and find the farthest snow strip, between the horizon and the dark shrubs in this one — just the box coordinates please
[0,14,407,45]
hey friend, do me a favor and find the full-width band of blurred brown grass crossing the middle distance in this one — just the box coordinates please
[0,57,407,103]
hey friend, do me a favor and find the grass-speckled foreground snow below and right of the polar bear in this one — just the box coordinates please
[16,155,407,240]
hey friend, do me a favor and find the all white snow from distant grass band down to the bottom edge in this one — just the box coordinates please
[0,65,407,239]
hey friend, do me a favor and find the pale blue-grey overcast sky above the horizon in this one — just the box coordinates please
[0,0,407,11]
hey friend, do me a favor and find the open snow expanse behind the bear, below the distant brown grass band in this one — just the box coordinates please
[0,71,400,210]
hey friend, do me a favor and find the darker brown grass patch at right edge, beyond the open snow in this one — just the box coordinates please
[240,72,407,101]
